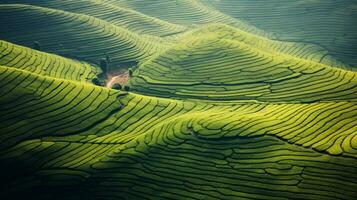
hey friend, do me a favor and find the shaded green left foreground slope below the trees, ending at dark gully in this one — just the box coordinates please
[0,67,121,149]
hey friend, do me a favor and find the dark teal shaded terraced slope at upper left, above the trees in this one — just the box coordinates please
[0,4,165,65]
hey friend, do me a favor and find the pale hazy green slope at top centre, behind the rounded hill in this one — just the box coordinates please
[104,0,268,37]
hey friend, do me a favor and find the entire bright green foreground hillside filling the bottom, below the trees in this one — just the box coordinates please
[0,67,357,199]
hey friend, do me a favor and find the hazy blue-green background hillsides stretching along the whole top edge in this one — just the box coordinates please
[0,0,357,67]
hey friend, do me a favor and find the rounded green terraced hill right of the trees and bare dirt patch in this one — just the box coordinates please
[130,25,357,102]
